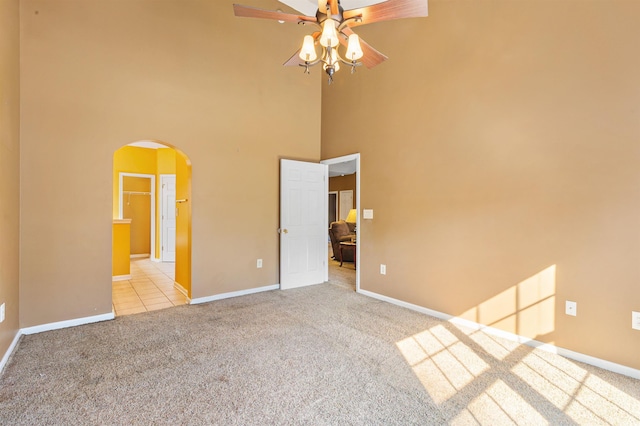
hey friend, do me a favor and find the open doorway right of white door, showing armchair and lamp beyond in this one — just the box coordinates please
[321,154,361,291]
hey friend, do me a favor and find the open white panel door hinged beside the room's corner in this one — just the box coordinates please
[280,160,329,290]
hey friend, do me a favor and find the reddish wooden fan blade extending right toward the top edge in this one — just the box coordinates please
[344,0,429,27]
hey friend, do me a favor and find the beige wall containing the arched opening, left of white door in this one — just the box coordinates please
[20,0,321,327]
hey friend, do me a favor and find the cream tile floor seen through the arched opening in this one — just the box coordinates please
[111,258,187,316]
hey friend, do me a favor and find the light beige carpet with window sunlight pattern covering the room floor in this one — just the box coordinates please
[0,284,640,425]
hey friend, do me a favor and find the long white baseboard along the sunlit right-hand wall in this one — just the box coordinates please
[358,290,640,379]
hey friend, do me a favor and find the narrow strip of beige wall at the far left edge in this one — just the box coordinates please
[0,0,20,359]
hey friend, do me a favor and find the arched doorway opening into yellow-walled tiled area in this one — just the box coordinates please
[112,140,191,316]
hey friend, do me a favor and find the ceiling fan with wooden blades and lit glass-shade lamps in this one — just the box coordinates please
[233,0,428,84]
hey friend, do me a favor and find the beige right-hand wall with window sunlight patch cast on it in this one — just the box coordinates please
[322,0,640,369]
